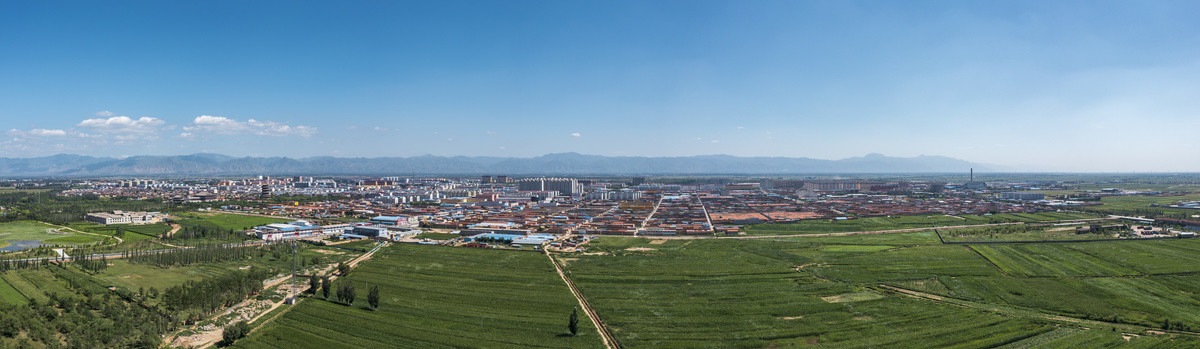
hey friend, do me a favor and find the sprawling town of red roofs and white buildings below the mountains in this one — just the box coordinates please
[44,169,1200,251]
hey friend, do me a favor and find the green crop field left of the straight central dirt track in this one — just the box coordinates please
[234,243,602,348]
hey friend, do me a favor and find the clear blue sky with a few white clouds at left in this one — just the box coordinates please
[0,0,1200,172]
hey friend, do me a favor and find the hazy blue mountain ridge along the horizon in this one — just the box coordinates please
[0,152,988,177]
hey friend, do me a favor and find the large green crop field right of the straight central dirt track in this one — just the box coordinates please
[560,236,1200,348]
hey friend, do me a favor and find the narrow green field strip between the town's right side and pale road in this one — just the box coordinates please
[744,212,1100,235]
